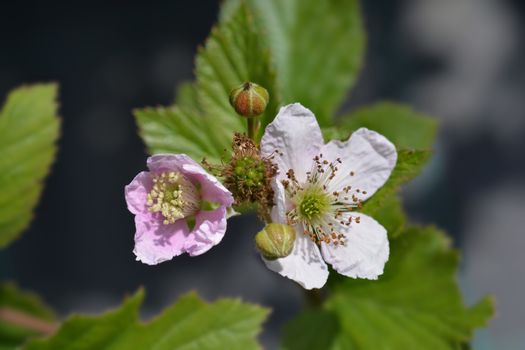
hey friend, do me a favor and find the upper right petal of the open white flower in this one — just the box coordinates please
[321,128,397,201]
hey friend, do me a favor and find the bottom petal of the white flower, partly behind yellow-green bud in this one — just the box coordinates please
[263,229,328,289]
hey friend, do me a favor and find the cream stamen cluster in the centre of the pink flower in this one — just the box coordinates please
[146,171,200,225]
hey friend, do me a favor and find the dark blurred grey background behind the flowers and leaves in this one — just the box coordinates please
[0,0,525,349]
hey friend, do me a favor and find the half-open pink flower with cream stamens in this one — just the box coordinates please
[125,154,233,265]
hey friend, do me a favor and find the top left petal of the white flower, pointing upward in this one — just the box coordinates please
[261,103,323,181]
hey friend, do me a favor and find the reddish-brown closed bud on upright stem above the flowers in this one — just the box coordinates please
[230,81,270,117]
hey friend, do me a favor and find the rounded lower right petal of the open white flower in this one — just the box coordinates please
[321,213,390,279]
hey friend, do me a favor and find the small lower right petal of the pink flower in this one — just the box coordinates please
[184,207,226,256]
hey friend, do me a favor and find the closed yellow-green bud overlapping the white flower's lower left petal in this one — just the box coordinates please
[255,223,295,260]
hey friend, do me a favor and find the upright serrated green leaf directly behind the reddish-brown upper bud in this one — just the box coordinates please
[196,3,279,133]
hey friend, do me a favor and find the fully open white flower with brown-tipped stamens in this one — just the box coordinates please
[261,103,397,289]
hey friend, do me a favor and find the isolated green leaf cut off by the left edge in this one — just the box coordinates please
[0,84,60,247]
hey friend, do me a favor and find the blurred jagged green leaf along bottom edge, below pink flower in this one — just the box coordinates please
[24,292,268,350]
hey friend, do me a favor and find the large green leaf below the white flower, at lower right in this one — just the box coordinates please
[284,227,493,350]
